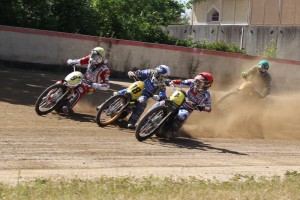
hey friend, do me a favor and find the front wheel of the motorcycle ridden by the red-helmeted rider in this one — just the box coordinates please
[135,106,168,142]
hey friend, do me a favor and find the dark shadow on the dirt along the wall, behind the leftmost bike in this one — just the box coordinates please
[0,66,126,106]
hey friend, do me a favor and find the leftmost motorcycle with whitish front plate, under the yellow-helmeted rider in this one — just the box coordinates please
[35,65,84,115]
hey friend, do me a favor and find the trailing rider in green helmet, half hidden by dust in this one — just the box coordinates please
[238,60,272,98]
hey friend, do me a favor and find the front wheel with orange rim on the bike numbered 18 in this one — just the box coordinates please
[96,94,128,126]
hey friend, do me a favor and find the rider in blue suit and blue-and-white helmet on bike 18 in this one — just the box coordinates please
[118,65,170,129]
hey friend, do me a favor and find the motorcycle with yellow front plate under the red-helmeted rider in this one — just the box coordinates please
[135,85,187,142]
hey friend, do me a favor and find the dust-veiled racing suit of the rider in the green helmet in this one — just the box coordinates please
[239,66,272,98]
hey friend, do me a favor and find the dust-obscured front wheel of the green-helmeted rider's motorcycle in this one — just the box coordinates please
[217,91,238,114]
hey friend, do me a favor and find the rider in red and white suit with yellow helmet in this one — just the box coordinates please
[62,47,110,114]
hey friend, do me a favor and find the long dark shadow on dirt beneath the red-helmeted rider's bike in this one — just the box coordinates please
[144,137,248,156]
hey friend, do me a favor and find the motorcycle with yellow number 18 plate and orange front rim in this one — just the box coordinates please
[96,77,145,127]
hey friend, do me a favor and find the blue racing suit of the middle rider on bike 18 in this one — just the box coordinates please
[118,69,167,126]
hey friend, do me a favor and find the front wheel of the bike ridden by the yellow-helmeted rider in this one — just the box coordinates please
[35,84,67,115]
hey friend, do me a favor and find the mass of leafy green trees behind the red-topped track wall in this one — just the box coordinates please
[0,0,245,52]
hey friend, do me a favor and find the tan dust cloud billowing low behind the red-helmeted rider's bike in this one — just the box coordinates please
[182,91,300,140]
